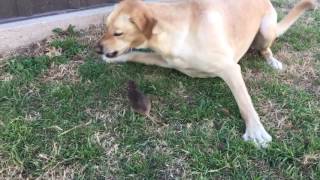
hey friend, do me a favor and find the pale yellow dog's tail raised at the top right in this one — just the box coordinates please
[277,0,317,37]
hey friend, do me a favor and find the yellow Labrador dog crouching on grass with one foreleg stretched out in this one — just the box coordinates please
[96,0,316,147]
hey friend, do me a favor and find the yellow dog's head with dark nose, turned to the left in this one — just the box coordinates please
[96,0,156,58]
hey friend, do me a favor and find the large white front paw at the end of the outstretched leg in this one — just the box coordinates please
[242,125,272,148]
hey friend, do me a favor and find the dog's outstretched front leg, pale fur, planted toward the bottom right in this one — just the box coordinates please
[220,64,272,147]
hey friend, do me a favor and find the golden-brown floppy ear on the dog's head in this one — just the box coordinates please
[130,6,157,39]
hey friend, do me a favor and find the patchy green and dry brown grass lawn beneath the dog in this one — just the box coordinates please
[0,2,320,179]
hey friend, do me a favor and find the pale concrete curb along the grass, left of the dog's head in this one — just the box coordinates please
[0,6,113,57]
